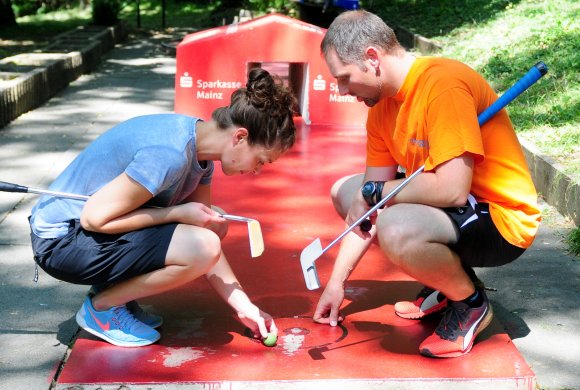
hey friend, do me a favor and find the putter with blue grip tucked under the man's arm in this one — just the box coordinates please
[300,61,548,290]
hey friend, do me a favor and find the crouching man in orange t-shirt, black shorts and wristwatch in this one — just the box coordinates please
[314,11,540,357]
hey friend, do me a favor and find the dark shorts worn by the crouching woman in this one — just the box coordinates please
[30,220,177,285]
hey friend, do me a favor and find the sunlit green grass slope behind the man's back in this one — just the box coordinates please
[439,0,580,180]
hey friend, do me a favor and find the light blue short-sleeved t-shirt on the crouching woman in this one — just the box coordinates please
[30,114,214,238]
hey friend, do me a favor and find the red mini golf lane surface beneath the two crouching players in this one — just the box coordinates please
[57,120,535,389]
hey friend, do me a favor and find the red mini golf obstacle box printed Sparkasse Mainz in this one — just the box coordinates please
[175,14,367,125]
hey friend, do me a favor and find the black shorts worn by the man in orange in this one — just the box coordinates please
[443,196,525,267]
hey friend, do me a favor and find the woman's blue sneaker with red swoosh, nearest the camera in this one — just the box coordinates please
[76,297,161,347]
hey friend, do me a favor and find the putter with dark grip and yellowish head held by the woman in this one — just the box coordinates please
[0,181,264,257]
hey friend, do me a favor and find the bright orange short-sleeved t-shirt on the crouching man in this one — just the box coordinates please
[367,57,540,248]
